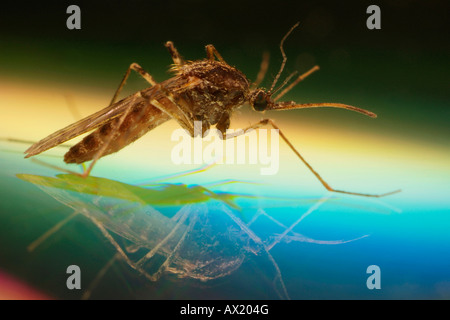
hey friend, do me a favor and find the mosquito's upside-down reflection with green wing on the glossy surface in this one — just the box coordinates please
[17,167,372,299]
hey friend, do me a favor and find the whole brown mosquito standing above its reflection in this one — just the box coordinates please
[25,23,400,197]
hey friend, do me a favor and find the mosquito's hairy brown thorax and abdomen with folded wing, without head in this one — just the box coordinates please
[26,60,250,163]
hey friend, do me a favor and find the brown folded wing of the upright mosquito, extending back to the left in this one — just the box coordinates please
[25,95,147,158]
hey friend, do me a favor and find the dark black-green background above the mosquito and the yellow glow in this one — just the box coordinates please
[0,0,450,142]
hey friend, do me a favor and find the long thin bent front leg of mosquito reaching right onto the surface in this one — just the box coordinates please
[224,119,400,198]
